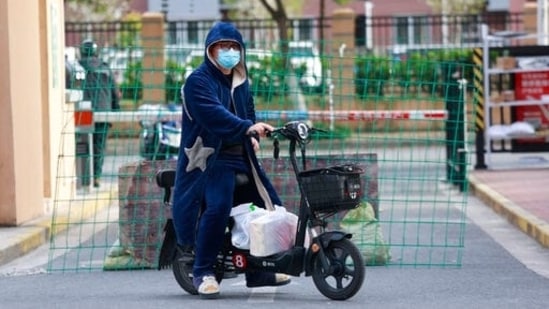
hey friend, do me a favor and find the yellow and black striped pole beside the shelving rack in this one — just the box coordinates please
[473,48,487,169]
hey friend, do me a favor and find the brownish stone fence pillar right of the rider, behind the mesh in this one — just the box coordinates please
[330,8,355,109]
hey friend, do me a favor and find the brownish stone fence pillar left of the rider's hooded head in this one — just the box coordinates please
[141,12,166,104]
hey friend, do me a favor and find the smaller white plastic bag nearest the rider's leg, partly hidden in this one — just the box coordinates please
[231,203,267,250]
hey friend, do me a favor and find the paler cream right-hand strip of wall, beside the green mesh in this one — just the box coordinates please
[41,0,76,211]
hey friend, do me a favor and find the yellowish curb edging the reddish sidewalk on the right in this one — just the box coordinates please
[468,175,549,248]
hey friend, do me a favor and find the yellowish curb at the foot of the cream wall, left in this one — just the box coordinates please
[0,189,118,266]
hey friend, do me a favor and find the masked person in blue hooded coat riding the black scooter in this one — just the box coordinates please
[173,22,290,298]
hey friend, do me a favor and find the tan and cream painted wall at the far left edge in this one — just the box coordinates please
[0,0,69,226]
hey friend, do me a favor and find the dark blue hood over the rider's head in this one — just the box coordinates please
[205,22,247,80]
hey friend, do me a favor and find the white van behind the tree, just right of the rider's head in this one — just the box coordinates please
[288,41,322,88]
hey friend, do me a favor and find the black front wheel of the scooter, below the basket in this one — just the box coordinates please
[312,238,366,300]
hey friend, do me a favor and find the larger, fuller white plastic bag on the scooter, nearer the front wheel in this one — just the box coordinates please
[250,206,297,256]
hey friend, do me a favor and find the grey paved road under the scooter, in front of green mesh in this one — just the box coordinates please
[0,191,549,309]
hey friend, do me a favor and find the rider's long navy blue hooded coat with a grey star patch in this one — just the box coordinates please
[173,22,281,241]
